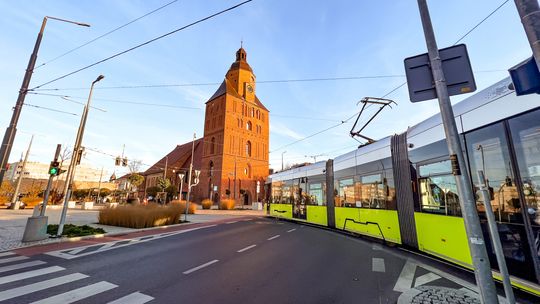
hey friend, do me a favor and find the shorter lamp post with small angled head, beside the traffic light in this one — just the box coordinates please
[57,75,105,237]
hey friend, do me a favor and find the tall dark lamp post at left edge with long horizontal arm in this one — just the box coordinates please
[0,16,90,184]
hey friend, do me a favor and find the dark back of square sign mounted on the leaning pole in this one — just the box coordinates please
[404,44,476,102]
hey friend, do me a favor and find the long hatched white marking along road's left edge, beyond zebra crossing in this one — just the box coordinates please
[45,225,217,260]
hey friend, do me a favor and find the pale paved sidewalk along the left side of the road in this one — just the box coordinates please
[0,208,265,252]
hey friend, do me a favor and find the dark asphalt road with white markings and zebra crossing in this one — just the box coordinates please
[0,217,532,304]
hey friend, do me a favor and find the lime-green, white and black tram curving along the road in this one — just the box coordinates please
[267,78,540,295]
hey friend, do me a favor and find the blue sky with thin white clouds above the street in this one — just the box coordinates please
[0,0,531,175]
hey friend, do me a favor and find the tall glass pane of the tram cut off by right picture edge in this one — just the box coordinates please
[509,111,540,255]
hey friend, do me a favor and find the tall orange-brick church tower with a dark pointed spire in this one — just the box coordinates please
[198,47,269,205]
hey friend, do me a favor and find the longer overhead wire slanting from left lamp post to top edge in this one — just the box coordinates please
[32,0,253,89]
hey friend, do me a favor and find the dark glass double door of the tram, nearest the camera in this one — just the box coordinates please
[465,118,540,281]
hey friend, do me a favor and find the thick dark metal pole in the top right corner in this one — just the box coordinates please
[514,0,540,70]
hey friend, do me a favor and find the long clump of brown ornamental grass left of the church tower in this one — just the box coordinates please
[98,203,185,228]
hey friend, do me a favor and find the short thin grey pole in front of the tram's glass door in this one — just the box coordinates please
[477,170,516,304]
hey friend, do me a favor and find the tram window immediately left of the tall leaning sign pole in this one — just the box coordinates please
[418,160,461,216]
